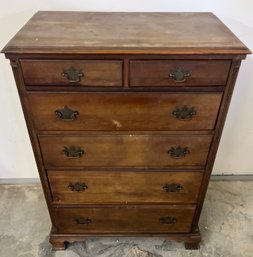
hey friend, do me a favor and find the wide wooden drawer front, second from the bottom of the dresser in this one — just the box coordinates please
[48,170,203,204]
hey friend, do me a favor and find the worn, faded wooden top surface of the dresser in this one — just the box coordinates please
[2,11,250,54]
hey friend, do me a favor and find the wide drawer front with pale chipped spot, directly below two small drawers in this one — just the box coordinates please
[28,93,222,131]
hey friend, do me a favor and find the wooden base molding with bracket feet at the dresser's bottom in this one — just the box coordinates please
[49,229,201,251]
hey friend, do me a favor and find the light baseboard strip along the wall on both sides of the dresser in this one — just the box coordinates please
[0,174,253,185]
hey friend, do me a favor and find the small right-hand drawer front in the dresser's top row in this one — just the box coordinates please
[129,60,230,86]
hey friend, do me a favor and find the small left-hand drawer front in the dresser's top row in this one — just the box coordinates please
[21,60,122,86]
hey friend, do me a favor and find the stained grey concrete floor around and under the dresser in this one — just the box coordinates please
[0,181,253,257]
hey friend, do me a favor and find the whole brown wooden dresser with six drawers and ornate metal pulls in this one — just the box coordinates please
[2,12,250,250]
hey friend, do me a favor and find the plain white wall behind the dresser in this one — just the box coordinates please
[0,0,253,178]
